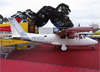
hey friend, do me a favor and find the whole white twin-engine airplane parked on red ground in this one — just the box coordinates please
[8,18,98,51]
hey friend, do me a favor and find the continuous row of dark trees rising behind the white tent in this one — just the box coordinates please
[12,3,74,29]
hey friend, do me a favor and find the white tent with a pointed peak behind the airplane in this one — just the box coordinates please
[39,20,56,34]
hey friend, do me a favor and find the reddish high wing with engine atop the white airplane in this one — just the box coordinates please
[57,27,94,37]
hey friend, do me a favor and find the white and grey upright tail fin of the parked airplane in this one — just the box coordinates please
[8,18,27,37]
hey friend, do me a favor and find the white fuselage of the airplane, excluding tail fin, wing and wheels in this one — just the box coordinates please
[27,33,97,46]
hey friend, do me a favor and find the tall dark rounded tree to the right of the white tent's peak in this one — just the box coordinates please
[52,3,74,30]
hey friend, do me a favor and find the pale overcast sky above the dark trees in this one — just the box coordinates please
[0,0,100,27]
